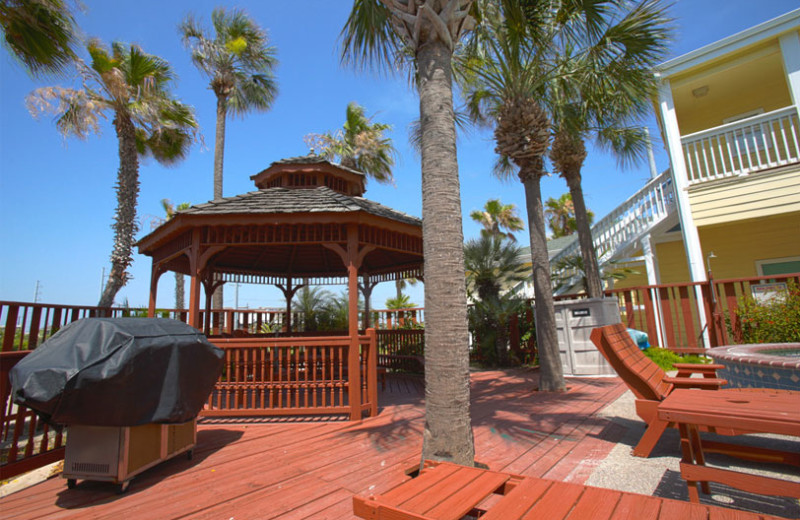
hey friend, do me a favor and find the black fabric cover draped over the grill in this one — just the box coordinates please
[11,318,224,426]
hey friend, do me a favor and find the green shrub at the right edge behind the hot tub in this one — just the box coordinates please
[736,280,800,343]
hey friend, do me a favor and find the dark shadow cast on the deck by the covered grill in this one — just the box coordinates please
[56,428,243,509]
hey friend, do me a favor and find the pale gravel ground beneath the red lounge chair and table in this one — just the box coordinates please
[586,391,800,518]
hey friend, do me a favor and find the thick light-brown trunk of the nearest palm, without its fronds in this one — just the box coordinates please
[417,41,475,466]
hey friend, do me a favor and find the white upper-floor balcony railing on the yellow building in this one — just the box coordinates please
[681,106,800,185]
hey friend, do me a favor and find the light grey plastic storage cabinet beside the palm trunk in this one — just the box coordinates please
[555,298,620,376]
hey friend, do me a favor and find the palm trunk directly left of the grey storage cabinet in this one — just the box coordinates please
[519,167,567,392]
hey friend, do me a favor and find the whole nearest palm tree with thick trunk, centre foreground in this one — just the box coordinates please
[342,0,475,465]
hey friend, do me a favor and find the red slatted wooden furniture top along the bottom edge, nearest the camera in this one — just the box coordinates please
[353,461,778,520]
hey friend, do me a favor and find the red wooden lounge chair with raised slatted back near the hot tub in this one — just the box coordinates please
[591,323,733,457]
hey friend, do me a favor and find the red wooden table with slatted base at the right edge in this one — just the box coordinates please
[658,389,800,502]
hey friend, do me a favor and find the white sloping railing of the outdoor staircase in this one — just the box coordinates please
[550,170,675,289]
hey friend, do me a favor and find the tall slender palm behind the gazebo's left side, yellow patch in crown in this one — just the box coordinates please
[179,8,278,309]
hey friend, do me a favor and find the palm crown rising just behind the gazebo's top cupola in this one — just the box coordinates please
[306,102,397,183]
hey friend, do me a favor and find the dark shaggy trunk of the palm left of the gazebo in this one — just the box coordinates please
[97,115,139,307]
